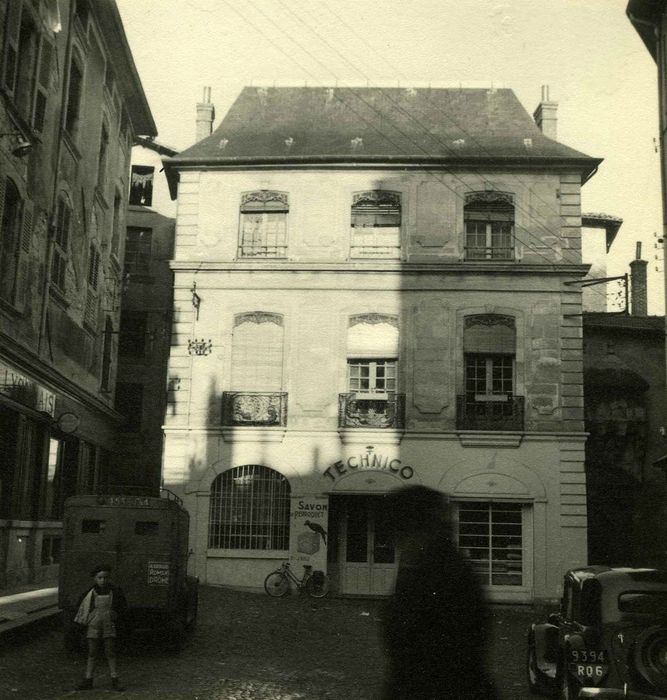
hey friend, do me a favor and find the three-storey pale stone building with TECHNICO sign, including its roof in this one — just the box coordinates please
[163,87,600,602]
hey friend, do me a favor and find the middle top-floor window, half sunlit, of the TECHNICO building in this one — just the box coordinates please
[350,190,401,258]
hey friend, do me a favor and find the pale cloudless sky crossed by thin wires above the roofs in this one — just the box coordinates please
[117,0,664,314]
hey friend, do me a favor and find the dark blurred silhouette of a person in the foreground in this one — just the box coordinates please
[383,486,498,700]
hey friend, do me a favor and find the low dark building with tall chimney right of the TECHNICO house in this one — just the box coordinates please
[583,245,667,566]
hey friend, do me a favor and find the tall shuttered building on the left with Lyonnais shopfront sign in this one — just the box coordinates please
[0,0,156,588]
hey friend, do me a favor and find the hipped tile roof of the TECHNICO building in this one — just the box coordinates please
[168,87,601,175]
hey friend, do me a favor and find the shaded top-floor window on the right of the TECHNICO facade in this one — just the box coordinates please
[463,191,514,260]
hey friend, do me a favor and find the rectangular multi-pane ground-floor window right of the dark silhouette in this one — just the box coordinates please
[458,502,524,586]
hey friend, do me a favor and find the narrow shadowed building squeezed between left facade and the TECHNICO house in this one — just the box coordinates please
[113,139,176,493]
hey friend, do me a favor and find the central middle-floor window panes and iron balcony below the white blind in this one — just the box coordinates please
[338,358,405,429]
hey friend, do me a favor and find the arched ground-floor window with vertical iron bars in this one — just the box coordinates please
[208,464,290,551]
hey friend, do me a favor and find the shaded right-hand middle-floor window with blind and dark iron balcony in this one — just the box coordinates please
[456,314,524,431]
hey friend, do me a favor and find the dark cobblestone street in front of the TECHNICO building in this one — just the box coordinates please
[0,586,534,700]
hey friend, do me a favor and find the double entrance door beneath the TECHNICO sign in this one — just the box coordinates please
[334,496,398,596]
